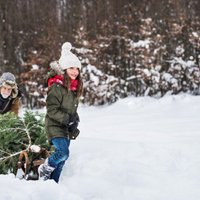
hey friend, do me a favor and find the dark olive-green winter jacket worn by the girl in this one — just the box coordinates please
[45,84,78,141]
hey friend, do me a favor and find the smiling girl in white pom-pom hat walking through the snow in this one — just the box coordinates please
[38,42,83,183]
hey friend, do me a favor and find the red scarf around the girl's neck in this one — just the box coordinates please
[47,75,78,91]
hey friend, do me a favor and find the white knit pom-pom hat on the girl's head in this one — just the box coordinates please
[58,42,81,70]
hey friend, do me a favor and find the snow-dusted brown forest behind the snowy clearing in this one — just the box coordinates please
[0,0,200,108]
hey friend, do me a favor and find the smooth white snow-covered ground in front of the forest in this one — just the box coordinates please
[0,95,200,200]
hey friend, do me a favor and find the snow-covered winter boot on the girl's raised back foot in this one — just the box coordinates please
[38,159,55,181]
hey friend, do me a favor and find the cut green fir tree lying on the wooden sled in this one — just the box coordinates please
[0,111,50,174]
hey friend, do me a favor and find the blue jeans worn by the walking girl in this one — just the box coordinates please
[48,137,70,183]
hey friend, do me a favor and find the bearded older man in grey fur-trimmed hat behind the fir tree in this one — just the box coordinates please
[0,72,21,115]
